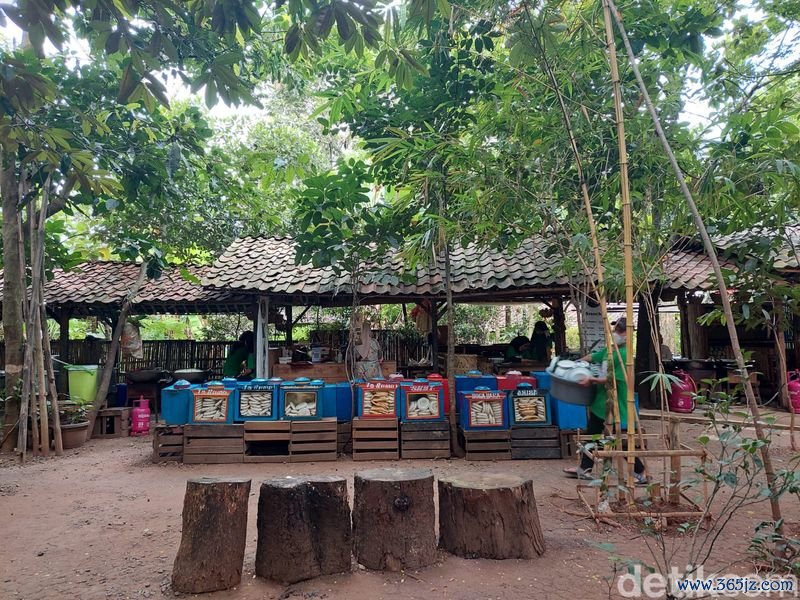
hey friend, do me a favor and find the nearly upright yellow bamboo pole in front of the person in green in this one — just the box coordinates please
[603,0,636,489]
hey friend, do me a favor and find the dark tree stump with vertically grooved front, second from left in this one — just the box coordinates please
[256,476,353,584]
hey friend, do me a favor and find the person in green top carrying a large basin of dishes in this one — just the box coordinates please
[564,317,647,485]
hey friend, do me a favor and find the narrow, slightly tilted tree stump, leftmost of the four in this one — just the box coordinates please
[172,477,250,594]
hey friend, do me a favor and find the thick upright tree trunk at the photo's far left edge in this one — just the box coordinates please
[0,150,25,450]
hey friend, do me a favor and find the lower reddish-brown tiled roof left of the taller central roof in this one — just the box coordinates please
[0,261,252,316]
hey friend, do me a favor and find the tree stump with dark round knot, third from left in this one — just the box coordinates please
[353,469,436,571]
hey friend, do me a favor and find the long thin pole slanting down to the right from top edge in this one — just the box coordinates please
[604,0,783,533]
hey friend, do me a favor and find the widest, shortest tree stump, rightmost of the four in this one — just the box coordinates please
[439,473,544,559]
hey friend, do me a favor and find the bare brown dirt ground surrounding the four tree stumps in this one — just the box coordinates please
[0,426,800,600]
